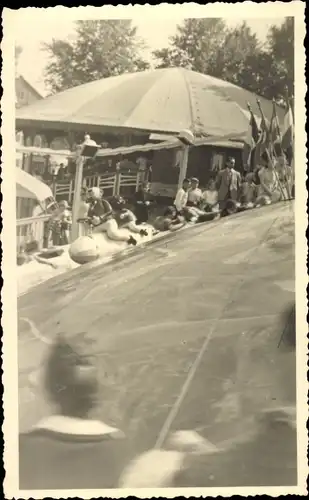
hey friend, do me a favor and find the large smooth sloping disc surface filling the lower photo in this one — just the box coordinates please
[18,203,296,486]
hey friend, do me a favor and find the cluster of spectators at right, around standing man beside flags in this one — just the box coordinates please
[174,155,293,221]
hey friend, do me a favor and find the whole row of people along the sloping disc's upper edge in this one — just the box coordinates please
[21,155,294,268]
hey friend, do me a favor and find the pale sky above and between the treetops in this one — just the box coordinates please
[14,4,283,95]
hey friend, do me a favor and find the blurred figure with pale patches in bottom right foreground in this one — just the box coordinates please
[120,407,297,488]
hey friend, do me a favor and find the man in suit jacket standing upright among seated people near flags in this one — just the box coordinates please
[217,157,241,209]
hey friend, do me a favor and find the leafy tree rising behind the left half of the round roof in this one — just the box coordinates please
[43,19,149,92]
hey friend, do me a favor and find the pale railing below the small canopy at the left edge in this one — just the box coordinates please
[16,215,50,248]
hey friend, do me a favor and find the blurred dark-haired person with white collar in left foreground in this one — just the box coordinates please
[19,336,132,490]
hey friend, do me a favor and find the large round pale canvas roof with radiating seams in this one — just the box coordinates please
[16,68,282,139]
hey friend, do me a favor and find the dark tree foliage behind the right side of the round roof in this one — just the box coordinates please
[153,18,294,102]
